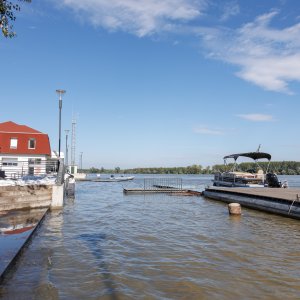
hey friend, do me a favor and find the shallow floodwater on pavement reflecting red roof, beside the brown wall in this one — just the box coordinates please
[0,209,47,278]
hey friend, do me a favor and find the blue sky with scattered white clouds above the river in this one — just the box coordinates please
[0,0,300,168]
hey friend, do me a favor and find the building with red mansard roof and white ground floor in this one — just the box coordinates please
[0,121,52,178]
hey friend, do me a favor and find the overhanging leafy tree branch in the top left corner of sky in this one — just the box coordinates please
[0,0,31,38]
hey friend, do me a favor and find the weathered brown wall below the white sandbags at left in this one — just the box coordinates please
[0,185,53,211]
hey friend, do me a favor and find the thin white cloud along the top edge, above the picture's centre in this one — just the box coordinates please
[60,0,207,36]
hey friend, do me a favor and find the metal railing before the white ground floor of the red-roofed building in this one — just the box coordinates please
[0,158,59,179]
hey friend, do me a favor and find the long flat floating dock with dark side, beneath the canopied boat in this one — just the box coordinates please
[203,187,300,220]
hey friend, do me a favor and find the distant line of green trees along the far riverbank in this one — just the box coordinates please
[80,161,300,175]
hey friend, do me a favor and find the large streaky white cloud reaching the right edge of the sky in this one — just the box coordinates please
[199,11,300,94]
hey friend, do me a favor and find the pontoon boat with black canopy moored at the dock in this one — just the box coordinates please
[213,151,287,187]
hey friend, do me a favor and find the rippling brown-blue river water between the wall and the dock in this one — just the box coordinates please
[0,176,300,300]
